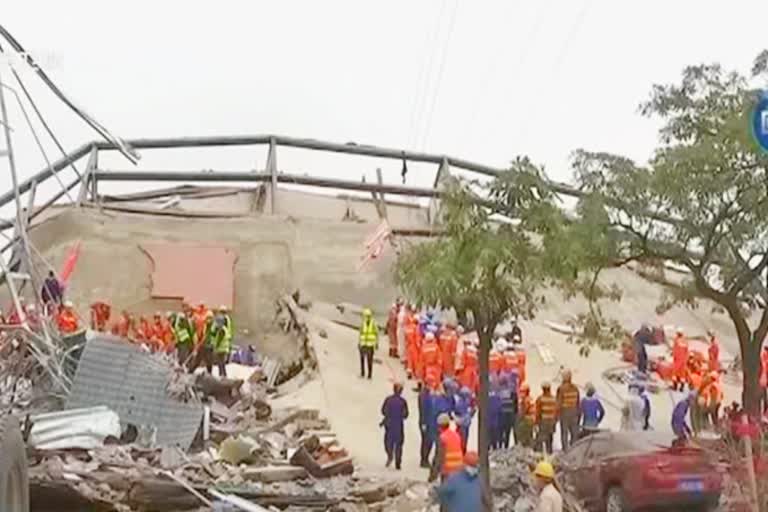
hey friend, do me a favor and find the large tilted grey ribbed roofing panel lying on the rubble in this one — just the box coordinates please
[67,335,203,450]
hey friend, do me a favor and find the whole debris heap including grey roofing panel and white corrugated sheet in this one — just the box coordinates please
[16,336,414,512]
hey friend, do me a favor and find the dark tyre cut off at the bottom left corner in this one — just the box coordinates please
[0,416,29,512]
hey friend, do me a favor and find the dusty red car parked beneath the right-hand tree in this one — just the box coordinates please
[557,431,723,512]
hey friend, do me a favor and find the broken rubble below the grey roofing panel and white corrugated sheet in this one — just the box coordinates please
[29,403,404,512]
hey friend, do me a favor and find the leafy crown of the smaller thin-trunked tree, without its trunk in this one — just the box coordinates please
[395,172,548,334]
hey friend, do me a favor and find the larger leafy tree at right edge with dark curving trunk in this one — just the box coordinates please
[573,52,768,412]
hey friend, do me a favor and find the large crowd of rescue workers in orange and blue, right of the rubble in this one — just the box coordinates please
[359,299,756,508]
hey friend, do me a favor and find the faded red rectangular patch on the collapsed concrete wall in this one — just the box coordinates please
[141,244,237,308]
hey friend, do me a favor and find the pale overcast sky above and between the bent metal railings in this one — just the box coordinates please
[0,0,768,208]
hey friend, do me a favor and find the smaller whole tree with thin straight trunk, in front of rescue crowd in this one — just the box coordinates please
[395,159,575,510]
